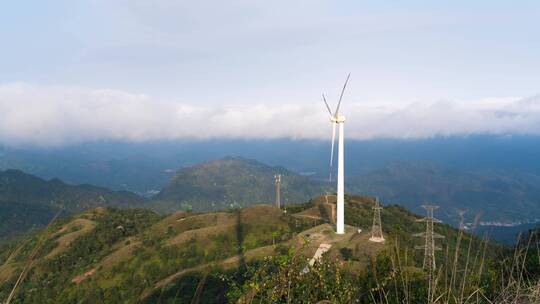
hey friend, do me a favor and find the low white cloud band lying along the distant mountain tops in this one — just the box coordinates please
[0,83,540,146]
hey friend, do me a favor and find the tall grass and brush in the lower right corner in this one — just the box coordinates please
[370,226,540,304]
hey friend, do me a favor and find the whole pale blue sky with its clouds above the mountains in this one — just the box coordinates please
[0,0,540,144]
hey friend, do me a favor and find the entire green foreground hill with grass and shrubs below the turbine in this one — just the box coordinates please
[0,196,540,303]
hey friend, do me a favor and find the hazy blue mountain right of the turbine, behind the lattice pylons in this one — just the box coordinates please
[349,162,540,223]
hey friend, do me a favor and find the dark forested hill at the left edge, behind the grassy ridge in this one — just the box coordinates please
[0,170,145,238]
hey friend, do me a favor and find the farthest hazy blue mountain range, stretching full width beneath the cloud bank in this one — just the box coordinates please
[0,136,540,193]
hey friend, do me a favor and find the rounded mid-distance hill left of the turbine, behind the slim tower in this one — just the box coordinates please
[155,157,324,211]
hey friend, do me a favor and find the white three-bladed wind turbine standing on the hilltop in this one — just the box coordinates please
[323,74,351,234]
